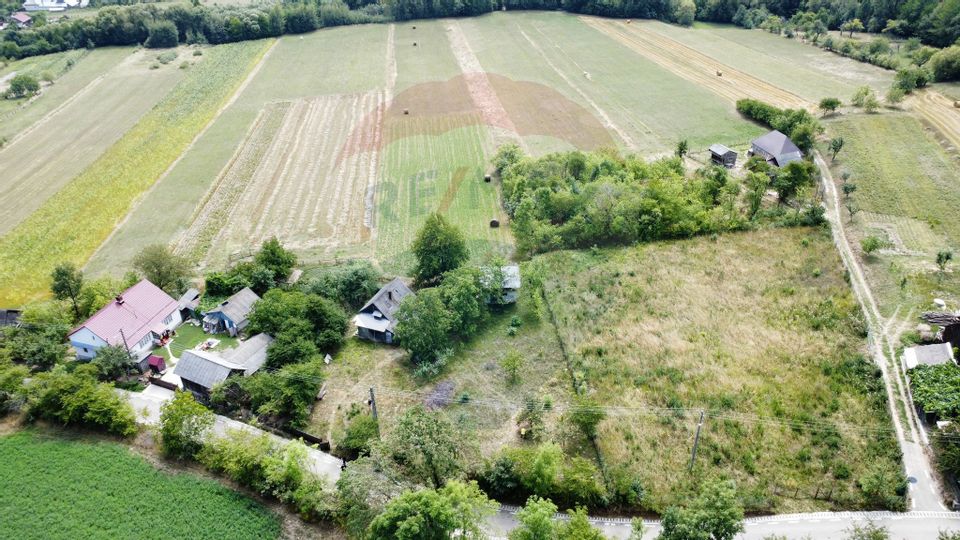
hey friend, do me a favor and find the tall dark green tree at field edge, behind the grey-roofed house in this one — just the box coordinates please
[412,212,470,285]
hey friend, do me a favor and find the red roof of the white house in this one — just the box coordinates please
[70,280,177,346]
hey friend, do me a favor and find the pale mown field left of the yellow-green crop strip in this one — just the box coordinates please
[0,49,186,235]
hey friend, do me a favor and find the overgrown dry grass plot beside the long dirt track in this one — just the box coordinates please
[535,228,900,512]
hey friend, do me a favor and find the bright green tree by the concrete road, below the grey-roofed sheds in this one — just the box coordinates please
[160,391,214,459]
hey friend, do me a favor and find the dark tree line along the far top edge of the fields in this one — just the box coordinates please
[0,0,960,62]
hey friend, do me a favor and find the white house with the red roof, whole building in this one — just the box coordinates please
[68,280,183,371]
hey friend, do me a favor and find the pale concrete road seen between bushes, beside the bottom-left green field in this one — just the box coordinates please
[120,385,340,485]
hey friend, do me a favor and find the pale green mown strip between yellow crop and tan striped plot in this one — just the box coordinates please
[87,25,387,274]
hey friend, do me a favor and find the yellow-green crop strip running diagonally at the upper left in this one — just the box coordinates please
[0,41,270,305]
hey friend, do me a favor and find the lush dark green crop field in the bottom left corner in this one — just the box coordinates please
[0,431,280,540]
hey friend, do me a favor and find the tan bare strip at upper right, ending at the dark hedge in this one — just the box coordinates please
[582,17,813,108]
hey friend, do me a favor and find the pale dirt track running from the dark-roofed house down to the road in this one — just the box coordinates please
[815,153,946,511]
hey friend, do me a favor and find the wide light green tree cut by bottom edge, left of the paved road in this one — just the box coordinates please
[368,481,500,540]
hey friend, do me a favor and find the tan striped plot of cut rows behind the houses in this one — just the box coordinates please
[178,92,384,266]
